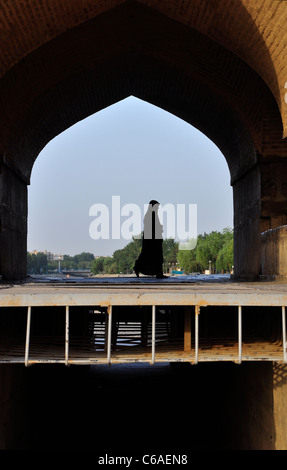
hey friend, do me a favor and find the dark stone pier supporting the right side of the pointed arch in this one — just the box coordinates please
[233,166,261,281]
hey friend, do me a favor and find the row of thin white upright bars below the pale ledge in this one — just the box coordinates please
[0,305,287,366]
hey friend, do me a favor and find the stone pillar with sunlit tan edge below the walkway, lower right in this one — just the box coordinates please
[230,361,287,450]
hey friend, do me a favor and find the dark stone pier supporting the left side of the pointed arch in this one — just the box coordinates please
[0,160,27,280]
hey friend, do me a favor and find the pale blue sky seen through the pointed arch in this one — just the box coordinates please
[28,97,233,256]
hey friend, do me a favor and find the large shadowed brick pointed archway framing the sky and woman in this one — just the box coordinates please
[0,0,287,279]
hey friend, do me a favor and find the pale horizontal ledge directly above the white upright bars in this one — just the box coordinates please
[0,280,287,307]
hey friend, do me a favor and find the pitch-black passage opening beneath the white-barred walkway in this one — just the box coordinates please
[19,363,254,455]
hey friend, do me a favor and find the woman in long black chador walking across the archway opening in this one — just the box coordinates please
[134,200,165,279]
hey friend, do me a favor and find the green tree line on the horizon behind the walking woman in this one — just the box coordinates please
[27,229,233,274]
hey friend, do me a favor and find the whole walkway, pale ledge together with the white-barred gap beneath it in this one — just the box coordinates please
[0,277,287,366]
